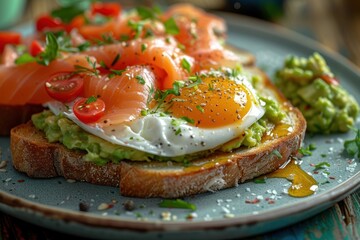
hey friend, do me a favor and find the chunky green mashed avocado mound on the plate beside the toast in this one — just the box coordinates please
[275,53,359,133]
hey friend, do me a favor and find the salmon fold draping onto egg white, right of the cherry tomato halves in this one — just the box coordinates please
[84,65,156,126]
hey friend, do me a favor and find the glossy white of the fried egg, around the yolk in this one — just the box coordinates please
[47,77,265,157]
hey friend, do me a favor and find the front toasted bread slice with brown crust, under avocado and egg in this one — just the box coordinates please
[10,68,306,198]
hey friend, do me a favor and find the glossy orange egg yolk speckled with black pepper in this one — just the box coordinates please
[168,77,252,128]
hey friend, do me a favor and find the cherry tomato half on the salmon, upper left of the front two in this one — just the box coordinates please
[45,72,84,103]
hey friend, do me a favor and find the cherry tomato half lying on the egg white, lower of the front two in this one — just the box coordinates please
[73,97,105,123]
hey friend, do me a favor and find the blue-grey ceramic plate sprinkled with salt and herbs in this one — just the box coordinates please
[0,14,360,239]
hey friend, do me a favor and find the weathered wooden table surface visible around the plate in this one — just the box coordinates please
[0,0,360,240]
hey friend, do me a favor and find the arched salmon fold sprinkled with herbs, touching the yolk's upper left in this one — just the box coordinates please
[84,37,194,89]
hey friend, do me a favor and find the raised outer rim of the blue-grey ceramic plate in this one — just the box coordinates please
[0,12,360,234]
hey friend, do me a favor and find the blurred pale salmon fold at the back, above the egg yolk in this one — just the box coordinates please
[163,4,244,71]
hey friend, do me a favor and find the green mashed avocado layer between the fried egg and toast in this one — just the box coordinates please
[32,90,285,165]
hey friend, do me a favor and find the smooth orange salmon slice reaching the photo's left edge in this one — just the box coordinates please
[0,54,94,105]
